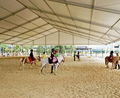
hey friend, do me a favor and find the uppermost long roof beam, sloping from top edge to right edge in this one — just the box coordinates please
[49,0,120,14]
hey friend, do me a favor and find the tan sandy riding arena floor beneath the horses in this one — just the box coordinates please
[0,57,120,98]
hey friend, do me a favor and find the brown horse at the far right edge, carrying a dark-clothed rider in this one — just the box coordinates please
[105,56,120,68]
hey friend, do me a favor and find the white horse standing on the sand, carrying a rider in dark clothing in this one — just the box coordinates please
[41,55,65,73]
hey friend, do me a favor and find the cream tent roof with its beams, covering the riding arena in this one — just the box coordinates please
[0,0,120,45]
